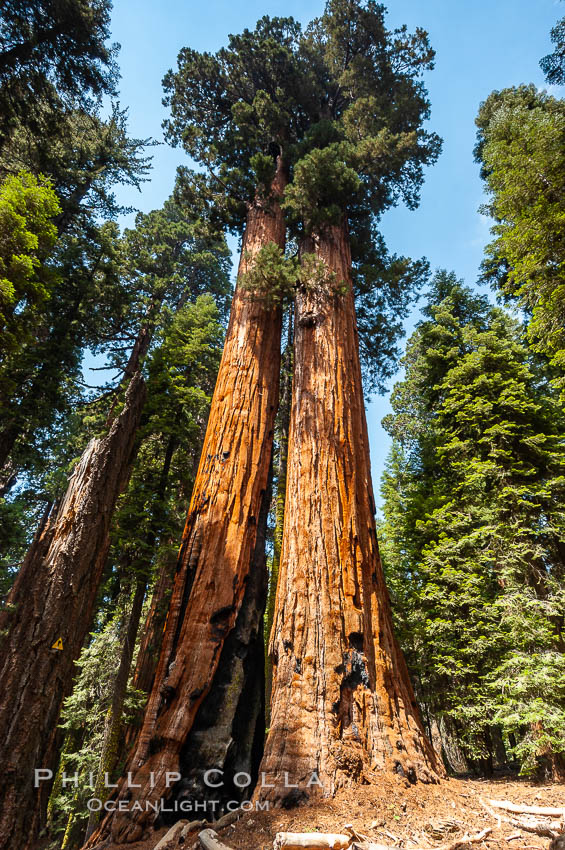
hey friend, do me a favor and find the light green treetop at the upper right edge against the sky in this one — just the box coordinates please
[476,85,565,402]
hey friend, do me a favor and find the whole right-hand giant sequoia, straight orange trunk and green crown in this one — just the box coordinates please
[257,0,439,804]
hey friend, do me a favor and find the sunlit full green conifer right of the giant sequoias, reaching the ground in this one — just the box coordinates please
[376,277,565,771]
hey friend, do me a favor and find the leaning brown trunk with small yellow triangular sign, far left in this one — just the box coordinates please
[0,373,145,850]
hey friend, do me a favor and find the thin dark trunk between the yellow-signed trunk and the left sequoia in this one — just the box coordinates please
[85,576,147,840]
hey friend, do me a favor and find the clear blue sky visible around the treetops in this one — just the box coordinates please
[104,0,565,504]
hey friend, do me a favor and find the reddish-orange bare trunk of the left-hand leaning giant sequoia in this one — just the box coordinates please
[91,160,285,845]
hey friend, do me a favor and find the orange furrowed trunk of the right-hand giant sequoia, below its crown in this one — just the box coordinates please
[256,220,438,806]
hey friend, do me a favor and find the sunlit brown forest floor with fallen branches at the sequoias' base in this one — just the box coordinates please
[120,776,565,850]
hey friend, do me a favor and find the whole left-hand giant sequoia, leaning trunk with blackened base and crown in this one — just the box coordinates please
[88,18,316,841]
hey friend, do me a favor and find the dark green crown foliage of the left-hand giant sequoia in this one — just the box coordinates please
[163,16,318,227]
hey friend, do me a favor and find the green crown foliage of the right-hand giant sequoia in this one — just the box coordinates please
[284,0,441,391]
